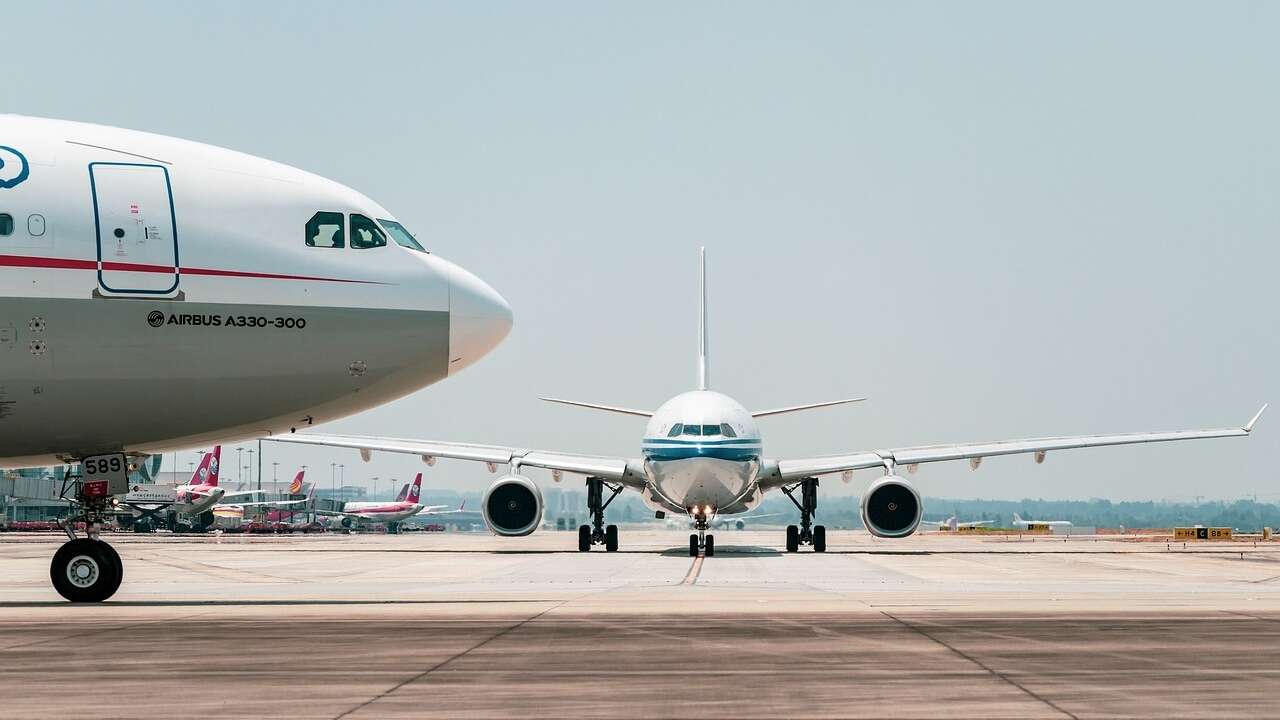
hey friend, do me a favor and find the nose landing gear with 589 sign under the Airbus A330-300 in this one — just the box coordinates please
[49,483,124,602]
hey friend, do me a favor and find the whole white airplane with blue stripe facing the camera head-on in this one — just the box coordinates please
[275,252,1266,556]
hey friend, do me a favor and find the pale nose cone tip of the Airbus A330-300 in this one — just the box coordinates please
[449,265,512,375]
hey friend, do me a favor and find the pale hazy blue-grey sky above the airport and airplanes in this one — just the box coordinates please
[0,1,1280,501]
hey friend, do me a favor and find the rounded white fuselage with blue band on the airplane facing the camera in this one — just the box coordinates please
[641,391,762,516]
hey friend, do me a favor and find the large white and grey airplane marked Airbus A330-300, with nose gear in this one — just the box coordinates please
[0,115,512,601]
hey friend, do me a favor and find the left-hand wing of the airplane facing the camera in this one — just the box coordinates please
[262,433,643,487]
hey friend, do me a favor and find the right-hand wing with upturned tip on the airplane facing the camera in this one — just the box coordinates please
[762,405,1267,487]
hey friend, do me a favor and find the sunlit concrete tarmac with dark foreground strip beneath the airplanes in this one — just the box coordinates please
[0,528,1280,719]
